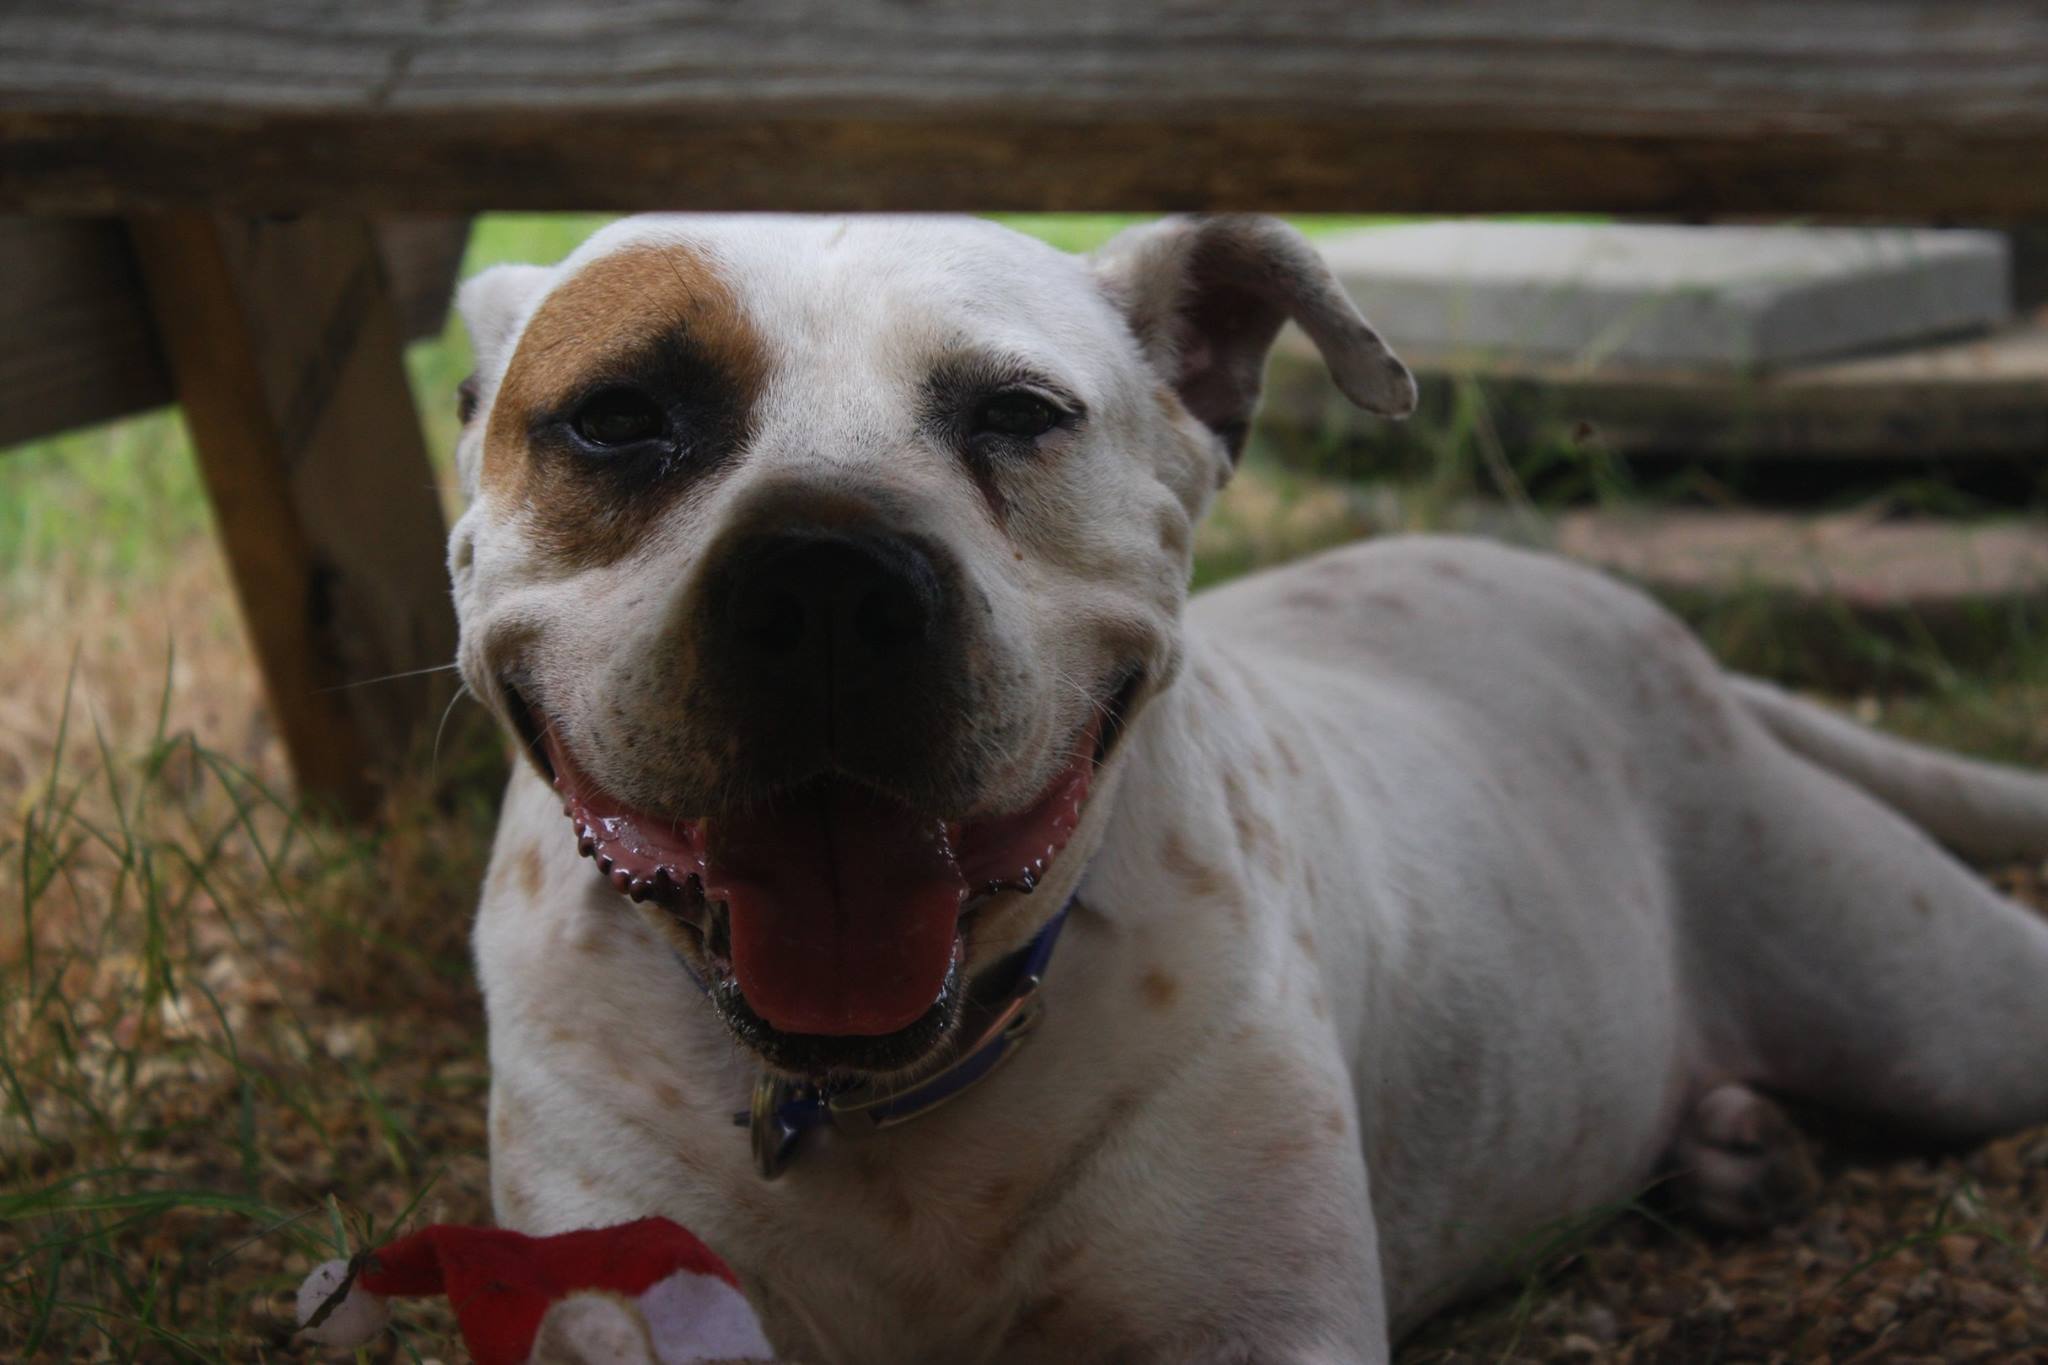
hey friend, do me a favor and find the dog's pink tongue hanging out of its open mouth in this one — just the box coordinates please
[705,782,969,1036]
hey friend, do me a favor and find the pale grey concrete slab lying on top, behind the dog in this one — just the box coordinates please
[1319,221,2011,370]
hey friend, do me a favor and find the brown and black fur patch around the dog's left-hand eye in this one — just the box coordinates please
[479,244,768,569]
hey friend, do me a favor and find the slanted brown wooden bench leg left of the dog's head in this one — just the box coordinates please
[131,213,455,814]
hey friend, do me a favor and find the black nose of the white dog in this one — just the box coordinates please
[723,530,940,684]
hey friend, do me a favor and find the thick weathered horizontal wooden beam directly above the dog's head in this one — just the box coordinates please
[0,0,2048,219]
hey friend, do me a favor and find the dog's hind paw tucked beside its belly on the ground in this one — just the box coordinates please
[1671,1085,1821,1232]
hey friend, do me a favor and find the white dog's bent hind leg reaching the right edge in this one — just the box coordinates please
[1681,737,2048,1140]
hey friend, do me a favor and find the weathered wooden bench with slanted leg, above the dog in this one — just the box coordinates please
[0,0,2048,810]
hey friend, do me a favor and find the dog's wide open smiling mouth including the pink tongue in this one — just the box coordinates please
[520,675,1137,1056]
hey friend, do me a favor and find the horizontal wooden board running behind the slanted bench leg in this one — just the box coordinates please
[0,217,469,452]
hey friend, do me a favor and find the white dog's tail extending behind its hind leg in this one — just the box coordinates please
[1731,677,2048,862]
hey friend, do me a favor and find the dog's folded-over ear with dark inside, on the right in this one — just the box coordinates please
[1092,213,1415,460]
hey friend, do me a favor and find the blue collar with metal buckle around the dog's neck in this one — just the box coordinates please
[733,900,1073,1181]
